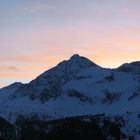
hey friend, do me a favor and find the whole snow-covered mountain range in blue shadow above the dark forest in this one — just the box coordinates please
[0,54,140,139]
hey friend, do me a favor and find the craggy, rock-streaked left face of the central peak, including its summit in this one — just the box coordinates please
[11,54,97,100]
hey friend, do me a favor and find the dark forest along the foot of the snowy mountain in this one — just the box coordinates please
[0,114,133,140]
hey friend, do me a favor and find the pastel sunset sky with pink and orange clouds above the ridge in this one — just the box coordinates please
[0,0,140,87]
